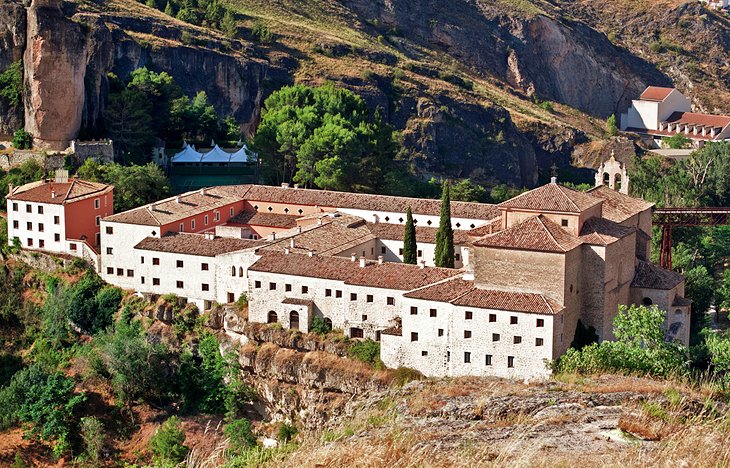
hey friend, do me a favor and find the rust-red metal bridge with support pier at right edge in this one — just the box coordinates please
[653,208,730,270]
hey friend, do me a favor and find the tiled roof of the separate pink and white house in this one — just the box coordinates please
[7,179,114,205]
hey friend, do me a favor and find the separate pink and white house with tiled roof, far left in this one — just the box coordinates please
[6,170,114,268]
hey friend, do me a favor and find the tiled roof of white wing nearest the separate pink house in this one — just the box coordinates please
[134,233,262,257]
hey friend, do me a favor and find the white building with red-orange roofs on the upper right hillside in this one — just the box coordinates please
[621,86,730,148]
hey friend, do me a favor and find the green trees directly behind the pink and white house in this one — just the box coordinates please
[76,159,170,212]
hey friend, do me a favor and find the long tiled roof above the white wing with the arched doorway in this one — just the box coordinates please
[249,253,459,291]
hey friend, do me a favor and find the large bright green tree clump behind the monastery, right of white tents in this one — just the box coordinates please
[254,84,395,191]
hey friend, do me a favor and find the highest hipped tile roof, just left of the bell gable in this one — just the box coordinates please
[497,183,601,213]
